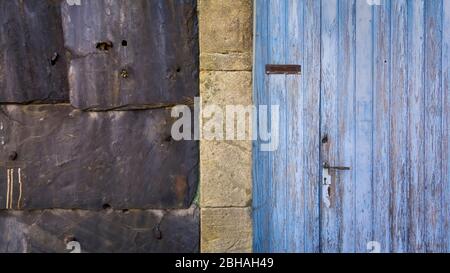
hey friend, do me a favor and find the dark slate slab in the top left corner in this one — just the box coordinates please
[0,0,69,103]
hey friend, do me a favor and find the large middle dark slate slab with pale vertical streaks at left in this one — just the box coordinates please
[0,104,198,209]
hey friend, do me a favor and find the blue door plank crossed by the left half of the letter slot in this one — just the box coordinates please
[268,0,288,252]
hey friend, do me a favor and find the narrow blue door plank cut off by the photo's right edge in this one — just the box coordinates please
[442,0,450,252]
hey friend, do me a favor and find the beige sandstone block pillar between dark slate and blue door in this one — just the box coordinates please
[198,0,253,252]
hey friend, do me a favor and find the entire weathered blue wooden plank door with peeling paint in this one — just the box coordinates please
[253,0,450,252]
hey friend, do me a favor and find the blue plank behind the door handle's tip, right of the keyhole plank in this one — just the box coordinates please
[338,0,356,252]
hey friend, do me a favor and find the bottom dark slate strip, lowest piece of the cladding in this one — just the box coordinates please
[0,208,199,253]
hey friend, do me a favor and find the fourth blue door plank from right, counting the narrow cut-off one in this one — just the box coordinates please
[389,0,409,252]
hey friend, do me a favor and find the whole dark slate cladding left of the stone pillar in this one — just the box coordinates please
[0,0,199,252]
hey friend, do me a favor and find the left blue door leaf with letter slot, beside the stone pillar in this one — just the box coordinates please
[253,0,320,252]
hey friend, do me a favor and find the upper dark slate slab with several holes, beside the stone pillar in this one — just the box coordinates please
[62,0,198,110]
